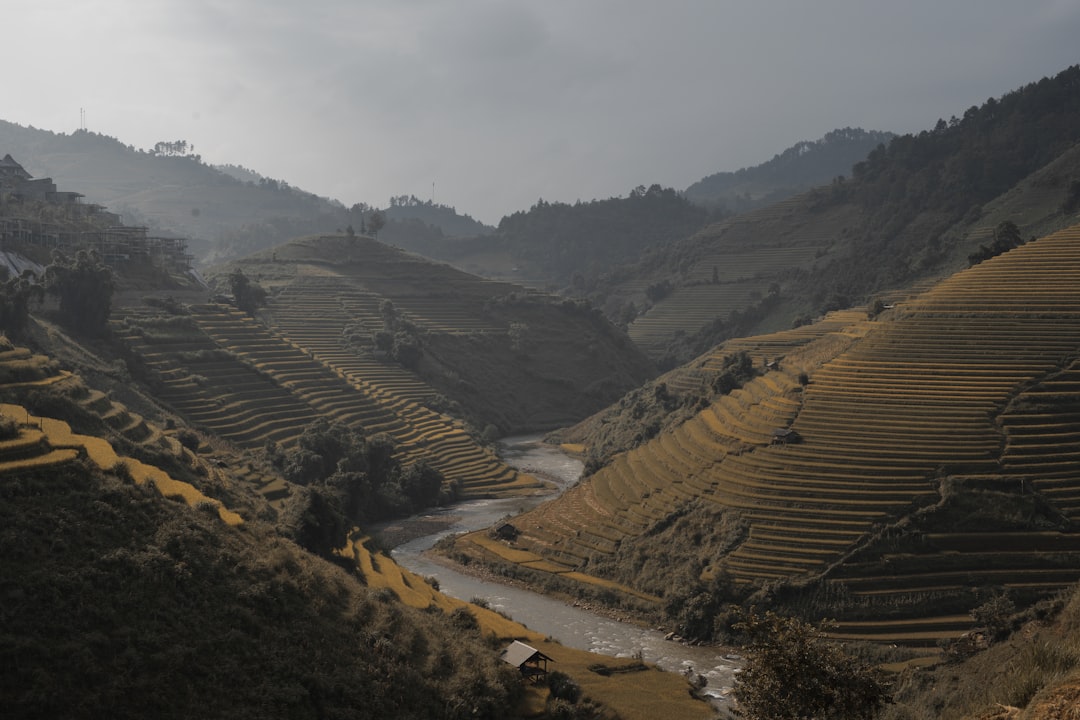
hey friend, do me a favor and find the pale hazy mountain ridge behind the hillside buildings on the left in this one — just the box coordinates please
[0,120,489,264]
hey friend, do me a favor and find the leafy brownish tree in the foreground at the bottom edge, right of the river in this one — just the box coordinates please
[733,609,890,720]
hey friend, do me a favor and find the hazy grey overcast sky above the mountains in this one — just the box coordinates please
[6,0,1080,223]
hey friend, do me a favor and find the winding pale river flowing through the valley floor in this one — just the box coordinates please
[391,435,738,707]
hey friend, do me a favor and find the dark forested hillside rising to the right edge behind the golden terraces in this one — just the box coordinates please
[592,67,1080,364]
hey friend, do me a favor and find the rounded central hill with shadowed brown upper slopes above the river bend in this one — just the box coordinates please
[210,235,653,434]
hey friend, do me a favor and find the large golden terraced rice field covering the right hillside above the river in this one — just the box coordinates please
[507,223,1080,641]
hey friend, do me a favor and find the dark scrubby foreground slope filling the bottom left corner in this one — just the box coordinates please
[0,465,515,718]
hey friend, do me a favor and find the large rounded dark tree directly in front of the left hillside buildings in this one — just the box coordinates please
[45,250,116,335]
